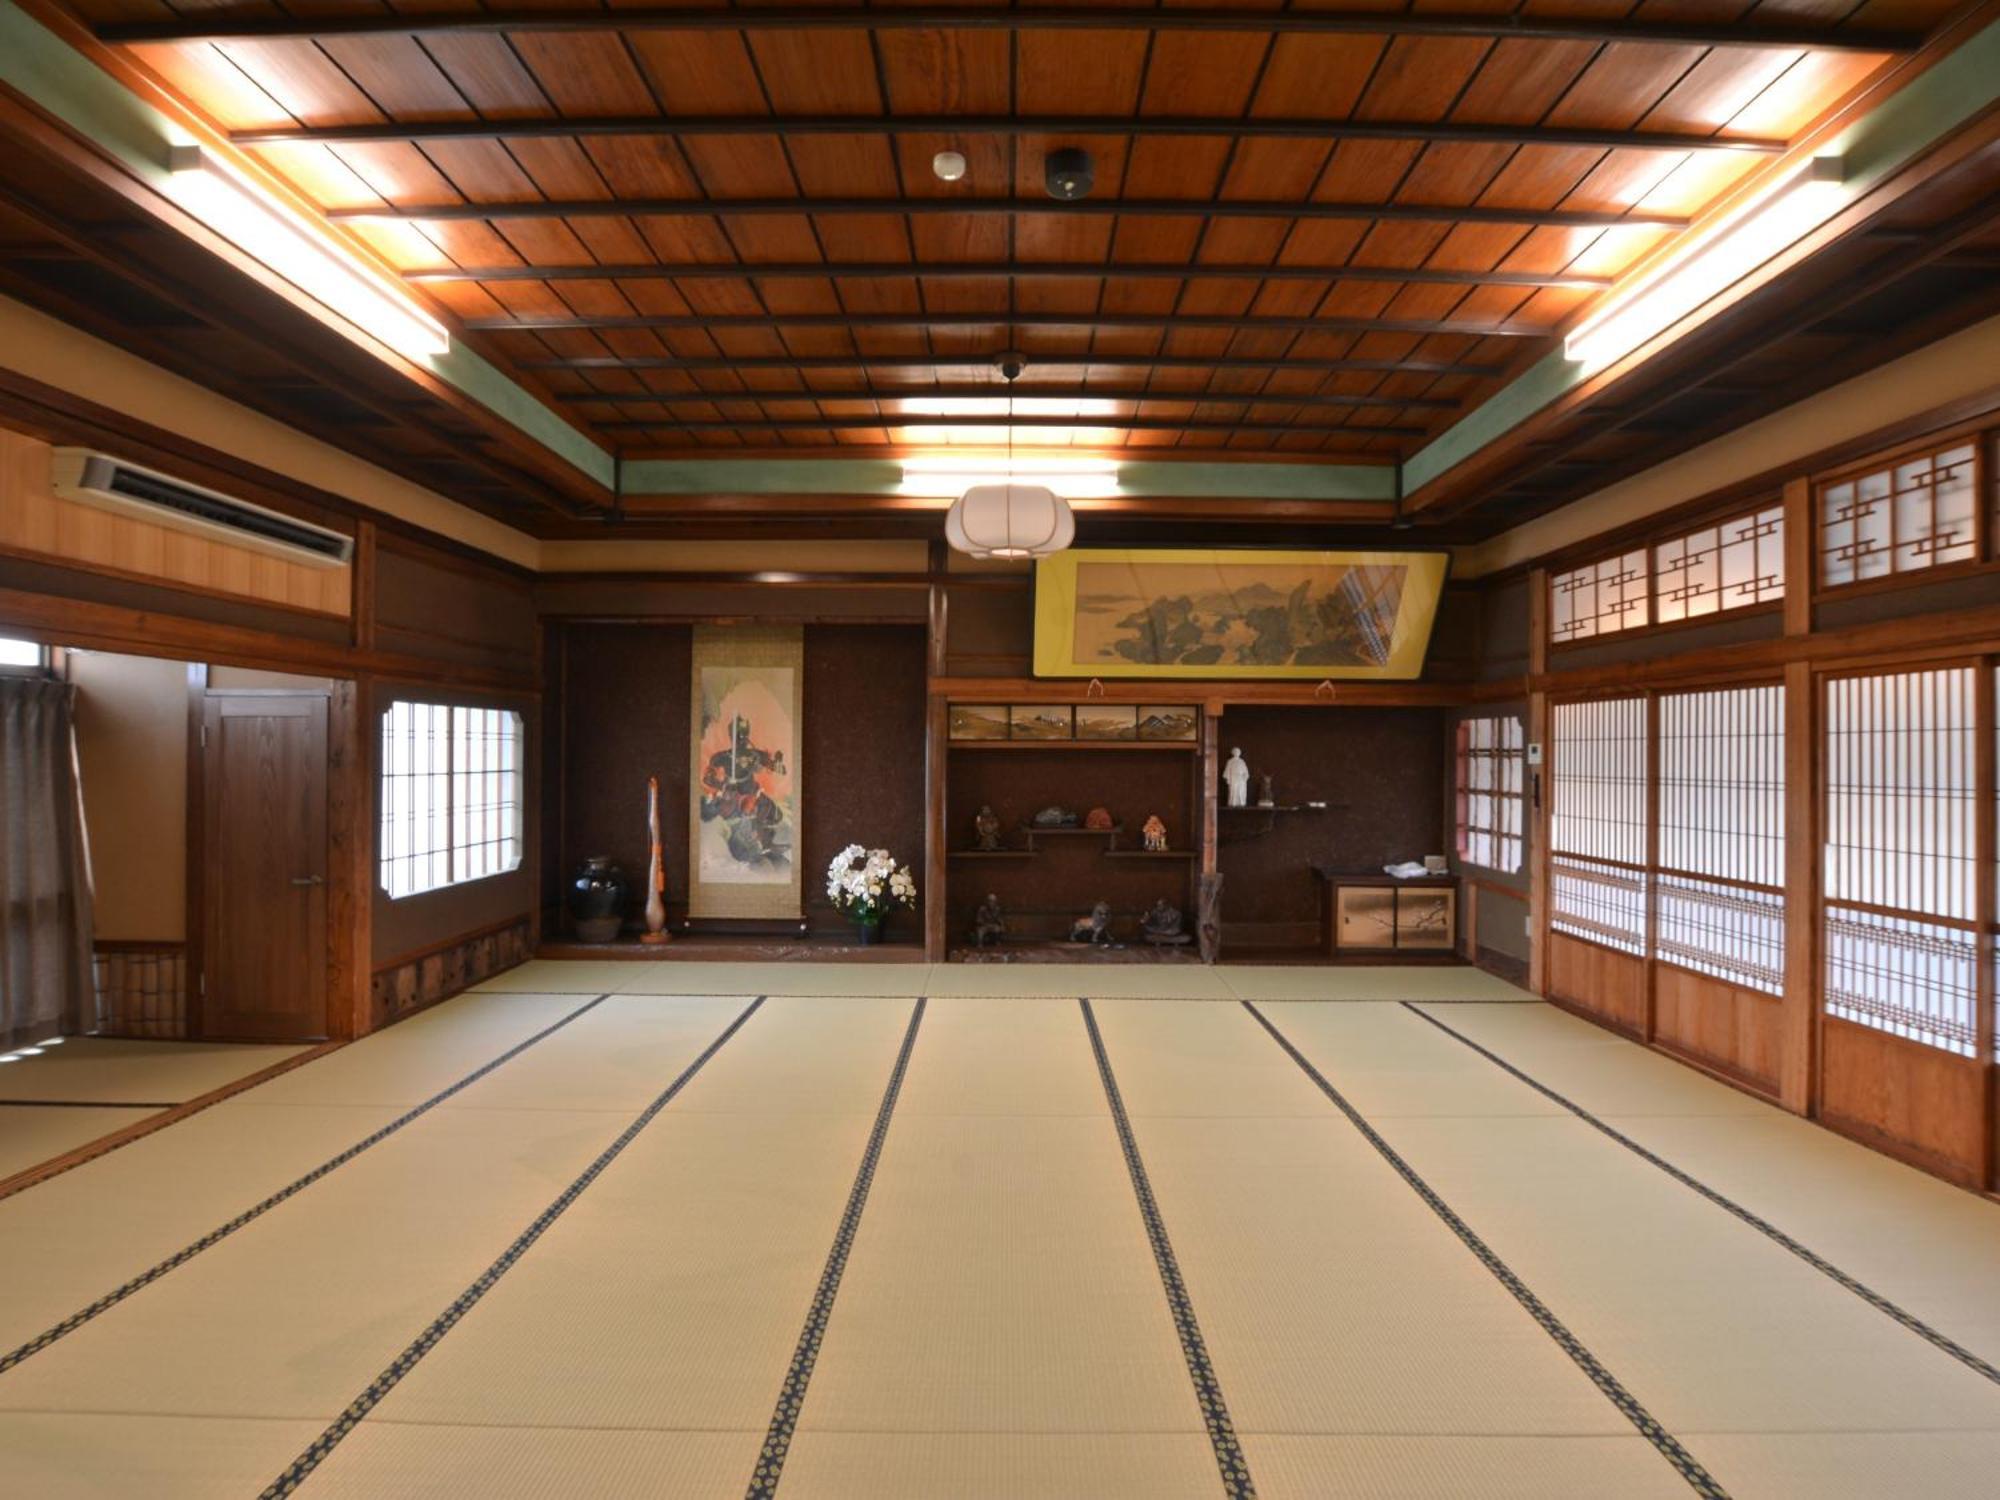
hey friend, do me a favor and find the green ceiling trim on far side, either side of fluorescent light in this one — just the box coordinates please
[622,450,1396,502]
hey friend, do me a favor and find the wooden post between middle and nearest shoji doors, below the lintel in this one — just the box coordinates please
[1778,656,1820,1114]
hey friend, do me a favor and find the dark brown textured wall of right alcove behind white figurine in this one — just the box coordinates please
[1220,708,1446,942]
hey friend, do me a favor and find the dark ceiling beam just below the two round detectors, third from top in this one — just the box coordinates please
[326,196,1688,230]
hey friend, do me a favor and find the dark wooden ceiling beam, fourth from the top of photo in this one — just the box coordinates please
[414,260,1612,292]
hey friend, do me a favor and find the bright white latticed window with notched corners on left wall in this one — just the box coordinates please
[380,700,524,898]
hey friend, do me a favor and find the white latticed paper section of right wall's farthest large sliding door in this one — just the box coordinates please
[1548,698,1648,956]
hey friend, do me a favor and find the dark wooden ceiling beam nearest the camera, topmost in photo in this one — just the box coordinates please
[96,6,1922,54]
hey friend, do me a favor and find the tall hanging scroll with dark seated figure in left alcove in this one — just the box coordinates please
[688,626,806,918]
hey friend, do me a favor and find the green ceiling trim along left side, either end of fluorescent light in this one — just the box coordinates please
[0,0,614,488]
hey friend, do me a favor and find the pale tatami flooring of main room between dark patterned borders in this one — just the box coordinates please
[0,962,2000,1500]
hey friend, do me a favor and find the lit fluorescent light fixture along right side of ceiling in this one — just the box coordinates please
[1562,156,1844,370]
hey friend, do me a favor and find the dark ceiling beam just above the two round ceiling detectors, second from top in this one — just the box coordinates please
[230,114,1788,156]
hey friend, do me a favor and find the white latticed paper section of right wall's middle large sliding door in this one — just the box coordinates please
[1654,686,1784,994]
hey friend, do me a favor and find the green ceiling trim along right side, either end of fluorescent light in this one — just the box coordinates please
[1404,20,2000,494]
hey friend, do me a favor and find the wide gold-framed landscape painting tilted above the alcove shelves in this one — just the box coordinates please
[1034,548,1450,680]
